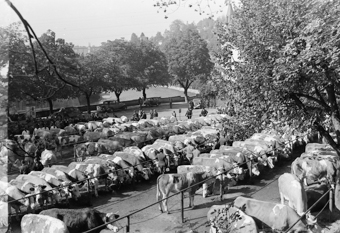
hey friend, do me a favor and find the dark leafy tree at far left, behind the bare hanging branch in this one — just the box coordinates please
[7,25,76,113]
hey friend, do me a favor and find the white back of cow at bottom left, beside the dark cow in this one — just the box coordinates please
[20,214,69,233]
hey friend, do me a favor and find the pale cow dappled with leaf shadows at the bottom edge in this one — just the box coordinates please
[207,205,259,233]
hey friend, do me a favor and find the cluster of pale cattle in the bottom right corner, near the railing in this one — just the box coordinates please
[207,143,340,233]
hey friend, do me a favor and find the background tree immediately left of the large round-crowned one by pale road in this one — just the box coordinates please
[130,34,170,99]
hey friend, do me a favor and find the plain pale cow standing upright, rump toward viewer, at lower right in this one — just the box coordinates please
[278,172,307,216]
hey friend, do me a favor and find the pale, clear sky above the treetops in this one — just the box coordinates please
[0,0,230,46]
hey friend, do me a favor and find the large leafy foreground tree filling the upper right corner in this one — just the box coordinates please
[218,0,340,155]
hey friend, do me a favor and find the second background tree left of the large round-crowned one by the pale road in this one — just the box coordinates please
[98,39,135,102]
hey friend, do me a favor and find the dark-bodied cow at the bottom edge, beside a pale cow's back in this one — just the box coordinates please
[40,208,119,233]
